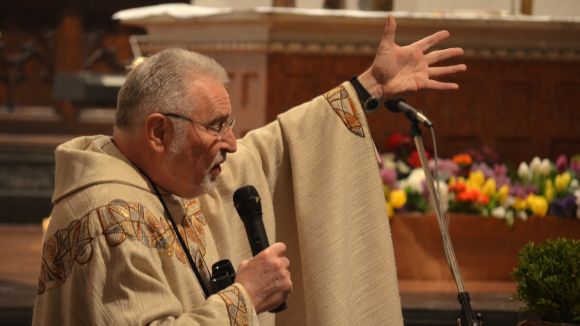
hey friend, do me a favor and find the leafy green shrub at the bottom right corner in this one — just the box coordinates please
[512,238,580,325]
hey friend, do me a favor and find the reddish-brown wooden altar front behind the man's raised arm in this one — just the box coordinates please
[267,54,580,166]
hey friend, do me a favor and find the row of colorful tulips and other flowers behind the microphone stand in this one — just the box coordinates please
[380,133,580,225]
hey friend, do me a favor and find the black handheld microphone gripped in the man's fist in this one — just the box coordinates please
[234,185,286,312]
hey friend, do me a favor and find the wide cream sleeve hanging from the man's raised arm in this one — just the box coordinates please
[226,83,402,325]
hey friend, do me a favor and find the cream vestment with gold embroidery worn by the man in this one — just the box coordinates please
[33,83,403,326]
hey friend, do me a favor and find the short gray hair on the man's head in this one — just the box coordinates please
[115,48,229,132]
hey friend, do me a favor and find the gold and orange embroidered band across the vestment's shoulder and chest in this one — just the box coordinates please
[38,199,207,295]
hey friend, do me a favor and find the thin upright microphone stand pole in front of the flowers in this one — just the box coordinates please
[406,119,483,326]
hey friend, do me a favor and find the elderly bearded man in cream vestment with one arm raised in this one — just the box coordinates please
[33,16,466,325]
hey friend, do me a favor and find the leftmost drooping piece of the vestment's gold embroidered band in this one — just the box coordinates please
[38,213,93,294]
